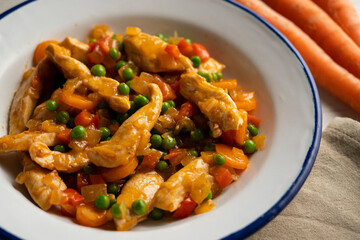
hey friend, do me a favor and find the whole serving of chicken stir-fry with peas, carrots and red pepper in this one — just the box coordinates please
[0,25,265,230]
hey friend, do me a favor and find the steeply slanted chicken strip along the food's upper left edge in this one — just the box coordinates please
[9,58,56,135]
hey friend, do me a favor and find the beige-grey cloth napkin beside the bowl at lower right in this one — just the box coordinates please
[248,117,360,240]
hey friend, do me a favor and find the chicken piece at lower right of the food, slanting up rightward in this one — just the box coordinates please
[154,158,209,212]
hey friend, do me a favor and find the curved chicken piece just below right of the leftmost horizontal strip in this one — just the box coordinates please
[29,142,90,173]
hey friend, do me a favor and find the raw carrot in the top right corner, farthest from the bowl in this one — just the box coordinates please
[313,0,360,47]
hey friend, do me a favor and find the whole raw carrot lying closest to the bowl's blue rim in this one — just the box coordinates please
[236,0,360,112]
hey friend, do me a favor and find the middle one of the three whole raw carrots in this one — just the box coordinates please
[263,0,360,78]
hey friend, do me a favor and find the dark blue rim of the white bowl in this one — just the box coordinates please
[0,0,322,240]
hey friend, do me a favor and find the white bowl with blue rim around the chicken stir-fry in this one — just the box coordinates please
[0,0,321,239]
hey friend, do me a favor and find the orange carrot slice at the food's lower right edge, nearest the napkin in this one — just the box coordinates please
[215,143,249,169]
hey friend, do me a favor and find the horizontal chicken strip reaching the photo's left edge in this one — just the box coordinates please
[0,131,58,153]
